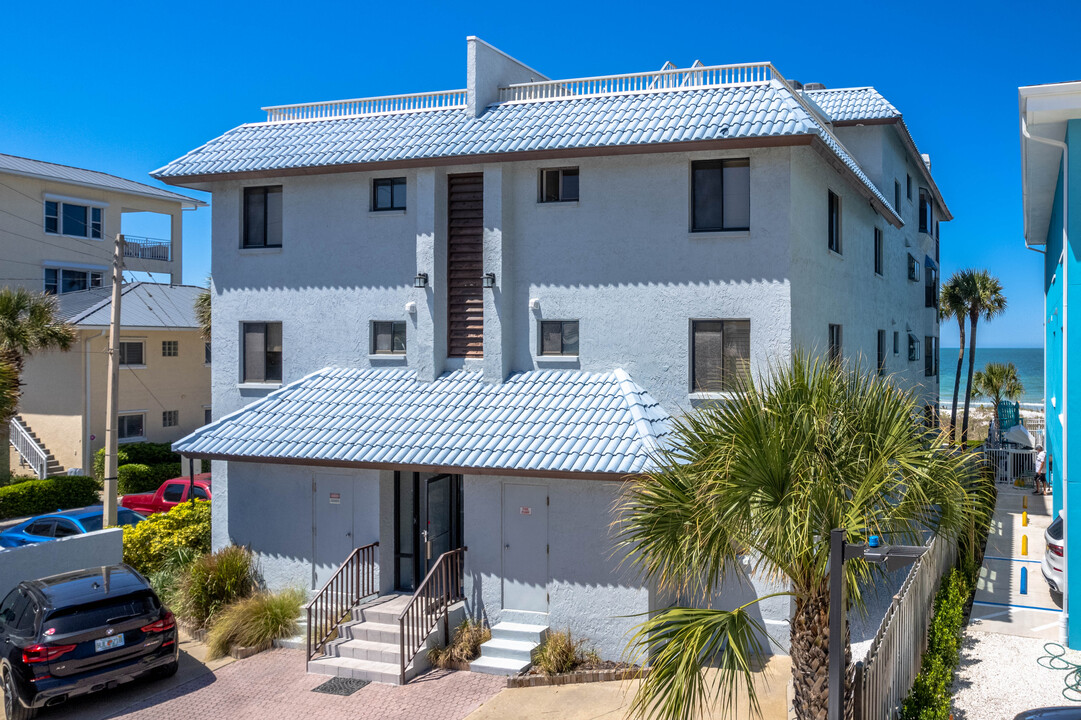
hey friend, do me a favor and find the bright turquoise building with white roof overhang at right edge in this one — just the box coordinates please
[1018,82,1081,650]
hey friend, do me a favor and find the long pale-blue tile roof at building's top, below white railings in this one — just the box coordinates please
[151,80,900,223]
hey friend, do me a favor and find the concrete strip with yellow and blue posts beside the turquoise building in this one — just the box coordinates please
[969,485,1063,640]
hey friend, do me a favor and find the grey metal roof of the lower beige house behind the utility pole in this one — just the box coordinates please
[56,282,205,330]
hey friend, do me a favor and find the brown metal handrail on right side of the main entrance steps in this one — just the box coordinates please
[398,547,468,685]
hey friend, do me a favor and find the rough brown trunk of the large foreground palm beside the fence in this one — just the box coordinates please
[791,586,854,720]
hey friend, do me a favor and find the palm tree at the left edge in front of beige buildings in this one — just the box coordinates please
[0,288,76,471]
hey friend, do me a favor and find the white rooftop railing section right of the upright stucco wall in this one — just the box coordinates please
[499,63,776,103]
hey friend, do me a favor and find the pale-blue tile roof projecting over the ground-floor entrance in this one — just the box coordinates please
[173,368,670,475]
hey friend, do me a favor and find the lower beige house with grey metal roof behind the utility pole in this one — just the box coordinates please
[11,282,211,475]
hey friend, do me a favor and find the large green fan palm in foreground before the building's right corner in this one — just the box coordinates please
[615,356,986,720]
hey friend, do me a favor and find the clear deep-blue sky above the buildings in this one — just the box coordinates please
[0,0,1081,347]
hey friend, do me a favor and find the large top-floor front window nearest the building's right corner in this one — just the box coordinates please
[691,158,750,232]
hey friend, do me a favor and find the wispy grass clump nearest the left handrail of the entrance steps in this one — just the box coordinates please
[206,590,307,659]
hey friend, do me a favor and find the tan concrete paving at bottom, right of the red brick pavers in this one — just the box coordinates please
[468,655,791,720]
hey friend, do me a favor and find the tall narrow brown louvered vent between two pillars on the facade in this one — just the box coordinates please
[446,173,484,358]
